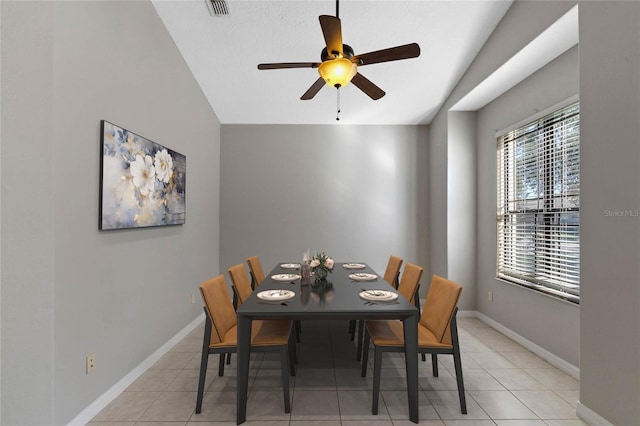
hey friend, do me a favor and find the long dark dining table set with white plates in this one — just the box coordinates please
[236,262,419,424]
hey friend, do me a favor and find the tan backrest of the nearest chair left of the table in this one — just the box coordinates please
[200,275,237,343]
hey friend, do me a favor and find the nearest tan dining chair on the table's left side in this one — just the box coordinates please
[196,275,295,414]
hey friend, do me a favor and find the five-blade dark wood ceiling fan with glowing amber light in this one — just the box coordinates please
[258,0,420,103]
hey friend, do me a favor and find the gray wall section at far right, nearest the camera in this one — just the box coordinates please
[580,1,640,425]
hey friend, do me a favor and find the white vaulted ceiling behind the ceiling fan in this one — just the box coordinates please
[153,0,511,124]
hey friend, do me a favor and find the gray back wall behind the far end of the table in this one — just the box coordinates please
[220,125,429,281]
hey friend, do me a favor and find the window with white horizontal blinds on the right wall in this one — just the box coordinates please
[497,102,580,303]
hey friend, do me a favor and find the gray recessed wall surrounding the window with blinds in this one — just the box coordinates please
[476,47,580,367]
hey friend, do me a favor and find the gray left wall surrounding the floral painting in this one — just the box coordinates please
[0,1,220,425]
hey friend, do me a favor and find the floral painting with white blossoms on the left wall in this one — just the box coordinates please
[100,120,186,230]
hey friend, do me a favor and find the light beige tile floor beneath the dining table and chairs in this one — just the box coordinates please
[89,317,586,426]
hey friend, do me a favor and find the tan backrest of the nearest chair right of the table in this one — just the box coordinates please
[420,275,462,343]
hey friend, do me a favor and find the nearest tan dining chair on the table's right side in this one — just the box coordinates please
[362,275,467,414]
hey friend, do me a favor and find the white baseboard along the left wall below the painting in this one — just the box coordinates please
[69,312,204,426]
